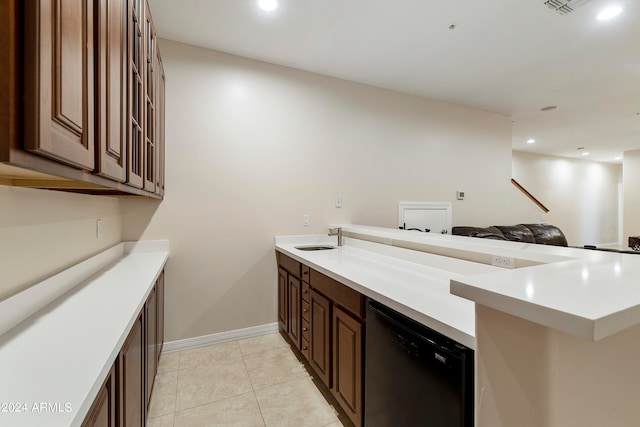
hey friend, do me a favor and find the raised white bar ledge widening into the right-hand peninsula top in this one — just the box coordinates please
[296,225,640,340]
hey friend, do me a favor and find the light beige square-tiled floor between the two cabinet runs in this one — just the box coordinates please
[147,333,342,427]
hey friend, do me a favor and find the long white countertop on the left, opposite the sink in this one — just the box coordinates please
[0,241,169,427]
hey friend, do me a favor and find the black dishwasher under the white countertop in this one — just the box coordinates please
[364,300,474,427]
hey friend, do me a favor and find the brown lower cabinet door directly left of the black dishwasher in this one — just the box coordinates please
[331,306,363,426]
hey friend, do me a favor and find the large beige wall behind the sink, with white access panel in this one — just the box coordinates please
[123,40,538,341]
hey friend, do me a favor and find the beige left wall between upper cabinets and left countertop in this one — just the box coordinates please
[0,185,122,299]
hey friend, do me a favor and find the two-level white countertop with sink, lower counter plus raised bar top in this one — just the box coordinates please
[276,225,640,347]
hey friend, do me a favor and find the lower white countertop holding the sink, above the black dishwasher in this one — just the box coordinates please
[276,232,499,349]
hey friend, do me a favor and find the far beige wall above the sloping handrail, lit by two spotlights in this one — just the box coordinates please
[512,151,620,245]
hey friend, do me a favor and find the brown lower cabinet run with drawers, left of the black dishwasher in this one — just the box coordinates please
[277,253,365,427]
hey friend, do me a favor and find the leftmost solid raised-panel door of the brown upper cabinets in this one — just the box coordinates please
[24,0,95,170]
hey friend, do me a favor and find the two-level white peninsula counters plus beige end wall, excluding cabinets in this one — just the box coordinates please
[276,225,640,427]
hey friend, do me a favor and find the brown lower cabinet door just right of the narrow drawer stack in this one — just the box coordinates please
[309,289,331,387]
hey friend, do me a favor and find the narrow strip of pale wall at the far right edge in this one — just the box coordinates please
[622,150,640,241]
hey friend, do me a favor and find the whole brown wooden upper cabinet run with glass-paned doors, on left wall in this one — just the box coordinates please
[0,0,165,198]
